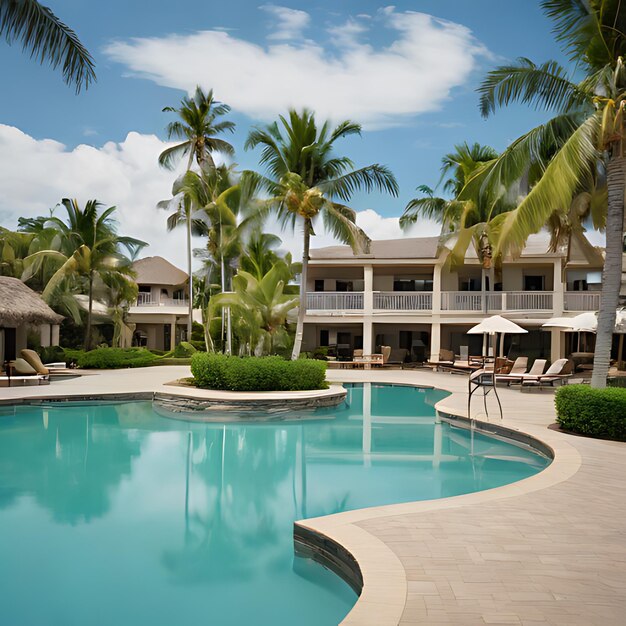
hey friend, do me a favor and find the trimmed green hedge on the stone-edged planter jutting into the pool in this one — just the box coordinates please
[191,352,328,391]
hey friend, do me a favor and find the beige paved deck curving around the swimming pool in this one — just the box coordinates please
[0,367,626,626]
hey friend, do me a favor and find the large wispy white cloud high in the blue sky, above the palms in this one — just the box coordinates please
[105,6,489,128]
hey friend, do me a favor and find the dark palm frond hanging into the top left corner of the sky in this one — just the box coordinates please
[0,0,96,93]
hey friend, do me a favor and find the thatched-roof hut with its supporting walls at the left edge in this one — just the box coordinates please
[0,276,63,369]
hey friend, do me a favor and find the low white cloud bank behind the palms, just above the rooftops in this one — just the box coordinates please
[0,124,439,268]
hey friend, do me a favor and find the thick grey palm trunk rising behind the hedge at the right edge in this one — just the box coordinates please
[591,155,626,389]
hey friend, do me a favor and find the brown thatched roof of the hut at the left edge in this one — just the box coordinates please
[0,276,63,326]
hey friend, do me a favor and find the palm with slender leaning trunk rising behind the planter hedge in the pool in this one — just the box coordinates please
[244,109,398,359]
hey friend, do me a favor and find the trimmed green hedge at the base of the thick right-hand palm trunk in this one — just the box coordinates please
[555,385,626,441]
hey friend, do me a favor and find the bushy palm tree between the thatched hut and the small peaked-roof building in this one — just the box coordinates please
[23,198,148,350]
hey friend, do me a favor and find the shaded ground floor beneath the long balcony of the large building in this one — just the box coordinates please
[302,316,608,365]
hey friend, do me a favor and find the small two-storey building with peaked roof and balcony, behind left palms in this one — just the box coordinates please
[128,256,189,350]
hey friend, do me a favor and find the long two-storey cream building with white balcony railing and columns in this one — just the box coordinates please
[303,234,603,361]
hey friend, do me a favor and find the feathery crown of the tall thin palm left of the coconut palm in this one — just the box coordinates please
[159,87,235,170]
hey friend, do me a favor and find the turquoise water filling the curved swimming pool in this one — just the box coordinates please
[0,385,548,626]
